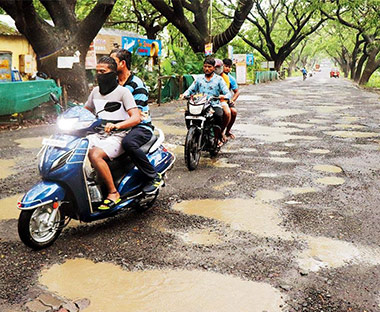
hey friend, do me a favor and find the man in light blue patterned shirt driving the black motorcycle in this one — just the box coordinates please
[181,57,230,145]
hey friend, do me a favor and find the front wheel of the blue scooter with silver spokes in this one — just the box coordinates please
[18,204,65,250]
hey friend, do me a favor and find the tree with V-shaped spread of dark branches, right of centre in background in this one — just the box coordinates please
[229,0,328,70]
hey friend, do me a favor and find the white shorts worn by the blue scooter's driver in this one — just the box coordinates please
[87,133,124,160]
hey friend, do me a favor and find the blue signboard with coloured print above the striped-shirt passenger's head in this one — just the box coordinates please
[121,37,161,56]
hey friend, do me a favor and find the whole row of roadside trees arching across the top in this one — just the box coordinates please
[0,0,380,100]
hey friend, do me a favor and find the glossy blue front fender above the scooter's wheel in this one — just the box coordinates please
[18,181,66,210]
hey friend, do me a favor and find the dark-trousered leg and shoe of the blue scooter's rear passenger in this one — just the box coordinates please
[122,127,161,193]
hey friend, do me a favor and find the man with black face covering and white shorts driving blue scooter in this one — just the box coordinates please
[84,56,140,210]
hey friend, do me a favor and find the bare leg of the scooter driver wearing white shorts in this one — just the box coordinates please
[88,147,120,202]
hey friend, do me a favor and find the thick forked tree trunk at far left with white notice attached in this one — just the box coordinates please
[0,0,116,101]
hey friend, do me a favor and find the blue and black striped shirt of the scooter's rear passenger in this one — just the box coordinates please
[124,74,152,130]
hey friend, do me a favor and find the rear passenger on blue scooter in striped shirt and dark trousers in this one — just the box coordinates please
[110,49,163,194]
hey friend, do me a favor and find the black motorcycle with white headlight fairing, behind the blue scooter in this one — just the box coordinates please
[185,95,220,170]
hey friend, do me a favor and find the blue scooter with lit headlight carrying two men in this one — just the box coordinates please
[18,95,175,250]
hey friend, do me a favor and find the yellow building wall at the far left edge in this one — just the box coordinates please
[0,35,37,73]
